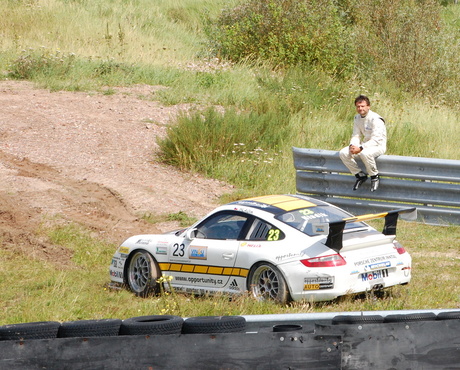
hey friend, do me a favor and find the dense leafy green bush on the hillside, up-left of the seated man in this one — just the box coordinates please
[208,0,354,74]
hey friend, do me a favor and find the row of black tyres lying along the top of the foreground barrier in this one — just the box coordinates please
[0,311,460,341]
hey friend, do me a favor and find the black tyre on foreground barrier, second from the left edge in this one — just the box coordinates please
[58,319,121,338]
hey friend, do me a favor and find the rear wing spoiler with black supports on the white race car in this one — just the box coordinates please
[312,207,417,253]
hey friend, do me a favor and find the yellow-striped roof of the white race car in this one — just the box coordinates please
[230,194,325,214]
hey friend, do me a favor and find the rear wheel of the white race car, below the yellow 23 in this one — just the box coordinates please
[248,262,291,303]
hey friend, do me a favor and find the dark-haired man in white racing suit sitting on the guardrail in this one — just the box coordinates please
[339,95,387,191]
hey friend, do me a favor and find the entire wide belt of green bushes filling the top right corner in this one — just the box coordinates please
[207,0,460,105]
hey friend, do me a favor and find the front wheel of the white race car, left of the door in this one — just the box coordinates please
[127,250,161,297]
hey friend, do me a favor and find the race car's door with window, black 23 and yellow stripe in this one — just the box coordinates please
[169,211,248,292]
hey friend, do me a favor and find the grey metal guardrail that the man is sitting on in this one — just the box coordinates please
[293,147,460,225]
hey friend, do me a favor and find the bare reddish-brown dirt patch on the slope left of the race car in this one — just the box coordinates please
[0,81,232,264]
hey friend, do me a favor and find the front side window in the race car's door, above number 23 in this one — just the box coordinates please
[195,212,247,240]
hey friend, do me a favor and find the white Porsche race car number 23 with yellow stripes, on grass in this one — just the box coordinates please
[110,195,416,303]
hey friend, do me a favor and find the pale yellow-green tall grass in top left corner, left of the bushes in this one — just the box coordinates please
[0,0,237,66]
